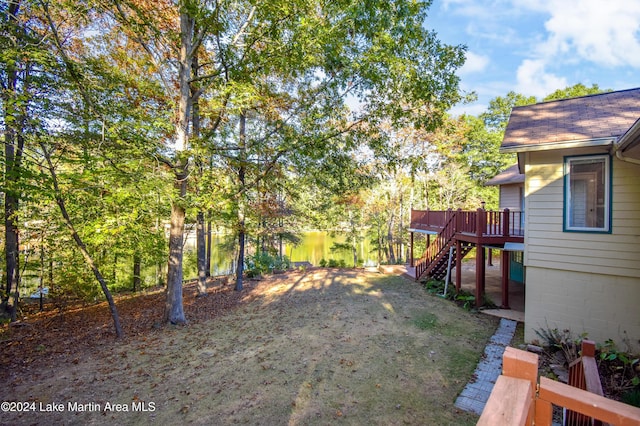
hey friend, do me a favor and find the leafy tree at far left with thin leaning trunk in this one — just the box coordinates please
[2,1,175,336]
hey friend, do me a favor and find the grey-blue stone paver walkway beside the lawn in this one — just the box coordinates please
[456,318,517,415]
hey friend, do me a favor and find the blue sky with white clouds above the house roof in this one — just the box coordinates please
[426,0,640,115]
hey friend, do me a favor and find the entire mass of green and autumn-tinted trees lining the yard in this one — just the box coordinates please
[0,0,612,336]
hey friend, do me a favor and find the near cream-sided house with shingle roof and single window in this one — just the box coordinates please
[500,88,640,352]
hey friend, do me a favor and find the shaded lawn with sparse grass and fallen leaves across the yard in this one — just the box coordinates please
[0,268,498,425]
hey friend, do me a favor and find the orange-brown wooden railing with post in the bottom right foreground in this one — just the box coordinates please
[477,347,640,426]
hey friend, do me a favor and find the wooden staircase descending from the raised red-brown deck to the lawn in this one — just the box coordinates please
[415,211,474,281]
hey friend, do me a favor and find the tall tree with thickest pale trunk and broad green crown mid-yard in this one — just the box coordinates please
[21,0,464,323]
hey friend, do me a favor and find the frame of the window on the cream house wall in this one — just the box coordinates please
[563,154,612,233]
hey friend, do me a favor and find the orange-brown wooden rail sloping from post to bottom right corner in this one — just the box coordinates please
[538,377,640,426]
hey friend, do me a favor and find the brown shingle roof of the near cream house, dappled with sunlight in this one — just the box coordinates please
[500,88,640,152]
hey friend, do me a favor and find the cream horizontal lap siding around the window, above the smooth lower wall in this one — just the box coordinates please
[525,149,640,277]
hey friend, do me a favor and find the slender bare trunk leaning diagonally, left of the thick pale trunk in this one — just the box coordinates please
[40,144,123,338]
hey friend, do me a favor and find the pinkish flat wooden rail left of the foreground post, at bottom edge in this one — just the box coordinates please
[477,376,533,426]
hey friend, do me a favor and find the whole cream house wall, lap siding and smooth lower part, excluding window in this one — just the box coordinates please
[525,149,640,351]
